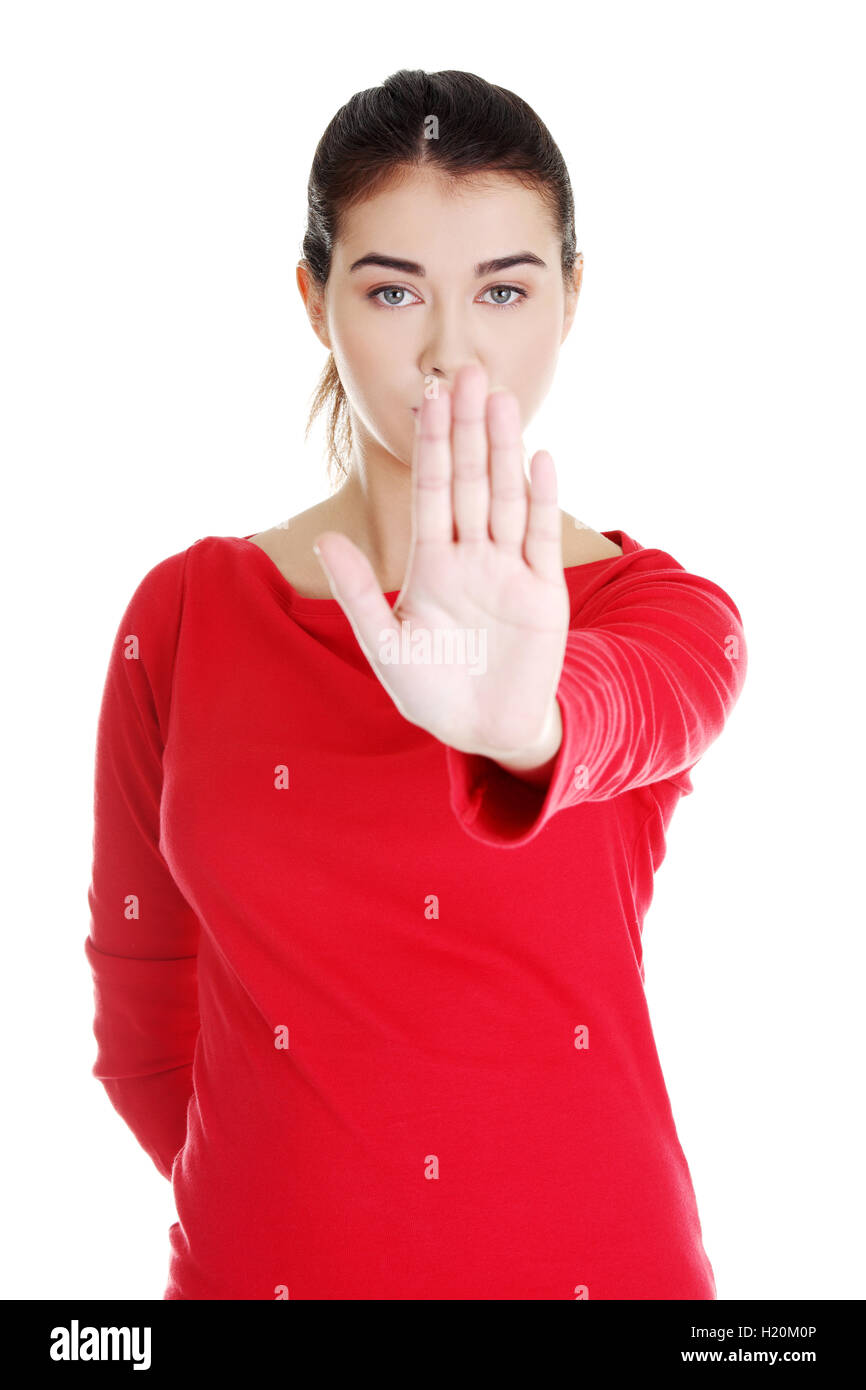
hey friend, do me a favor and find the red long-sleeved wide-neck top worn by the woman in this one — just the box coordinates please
[85,531,746,1300]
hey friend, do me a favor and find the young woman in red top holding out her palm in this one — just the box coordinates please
[86,71,746,1300]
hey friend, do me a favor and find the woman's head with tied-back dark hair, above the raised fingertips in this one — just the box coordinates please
[297,70,582,494]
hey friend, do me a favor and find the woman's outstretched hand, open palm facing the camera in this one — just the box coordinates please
[309,366,570,771]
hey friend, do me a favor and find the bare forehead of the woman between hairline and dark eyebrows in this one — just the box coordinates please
[334,170,555,274]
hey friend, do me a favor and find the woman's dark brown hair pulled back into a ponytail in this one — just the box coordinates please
[303,68,577,494]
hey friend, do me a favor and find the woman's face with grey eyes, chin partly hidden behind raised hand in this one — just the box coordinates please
[297,170,582,466]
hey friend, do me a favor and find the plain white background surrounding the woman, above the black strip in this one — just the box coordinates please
[0,0,866,1300]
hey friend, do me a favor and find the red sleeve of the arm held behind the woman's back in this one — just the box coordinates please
[85,552,200,1179]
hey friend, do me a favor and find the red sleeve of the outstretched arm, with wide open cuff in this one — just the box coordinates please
[445,549,748,848]
